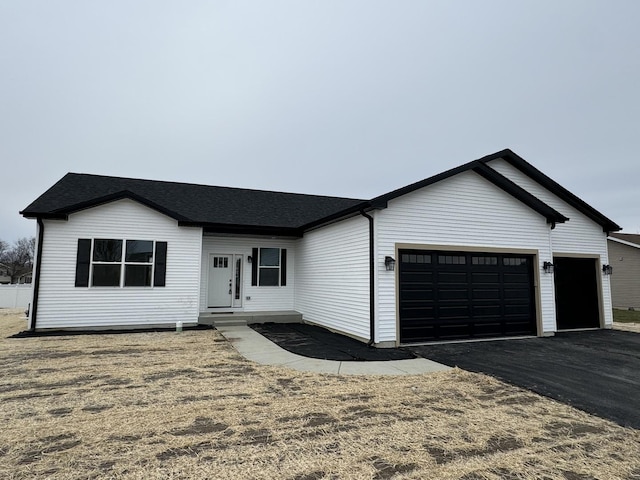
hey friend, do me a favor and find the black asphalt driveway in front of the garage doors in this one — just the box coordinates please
[407,330,640,429]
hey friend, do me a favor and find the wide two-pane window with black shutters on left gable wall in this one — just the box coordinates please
[76,238,167,287]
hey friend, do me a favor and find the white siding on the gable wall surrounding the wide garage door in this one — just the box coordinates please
[376,171,555,341]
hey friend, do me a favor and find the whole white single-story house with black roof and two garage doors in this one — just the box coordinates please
[21,150,620,346]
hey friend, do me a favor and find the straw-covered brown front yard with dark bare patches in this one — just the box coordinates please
[0,311,640,480]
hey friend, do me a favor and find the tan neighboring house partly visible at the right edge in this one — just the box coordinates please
[609,233,640,309]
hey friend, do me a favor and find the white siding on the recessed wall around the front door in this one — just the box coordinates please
[200,236,297,312]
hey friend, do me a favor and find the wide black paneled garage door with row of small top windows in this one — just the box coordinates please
[398,250,536,343]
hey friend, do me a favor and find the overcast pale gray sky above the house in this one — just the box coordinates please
[0,0,640,241]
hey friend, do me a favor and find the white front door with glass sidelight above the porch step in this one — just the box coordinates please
[207,254,242,308]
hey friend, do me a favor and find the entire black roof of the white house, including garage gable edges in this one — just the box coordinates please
[20,149,621,236]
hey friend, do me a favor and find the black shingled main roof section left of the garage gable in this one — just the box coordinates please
[21,173,364,233]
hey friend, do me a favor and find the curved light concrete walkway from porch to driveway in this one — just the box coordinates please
[216,325,451,375]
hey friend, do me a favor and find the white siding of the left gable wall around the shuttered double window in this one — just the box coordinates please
[36,200,202,328]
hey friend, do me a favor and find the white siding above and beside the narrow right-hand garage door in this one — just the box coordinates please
[489,159,613,325]
